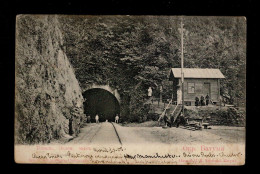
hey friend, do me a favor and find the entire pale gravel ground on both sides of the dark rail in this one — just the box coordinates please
[63,122,245,145]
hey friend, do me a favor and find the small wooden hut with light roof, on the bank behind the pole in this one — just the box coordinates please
[169,68,225,106]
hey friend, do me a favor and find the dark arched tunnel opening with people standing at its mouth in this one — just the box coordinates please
[83,88,120,122]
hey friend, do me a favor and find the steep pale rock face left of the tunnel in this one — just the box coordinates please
[15,15,85,144]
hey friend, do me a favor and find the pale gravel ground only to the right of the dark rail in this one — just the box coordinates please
[117,123,245,144]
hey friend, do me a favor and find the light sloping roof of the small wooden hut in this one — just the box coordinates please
[170,68,225,79]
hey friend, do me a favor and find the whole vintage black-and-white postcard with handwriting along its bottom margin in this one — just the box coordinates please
[14,15,246,165]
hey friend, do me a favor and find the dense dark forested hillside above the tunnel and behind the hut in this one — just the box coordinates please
[59,16,246,120]
